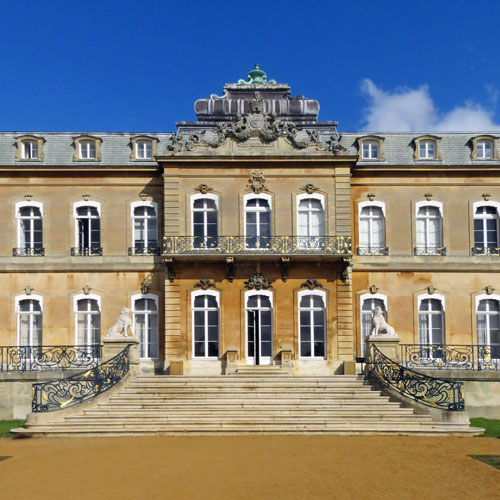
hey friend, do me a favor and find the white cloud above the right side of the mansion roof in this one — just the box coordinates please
[361,79,500,132]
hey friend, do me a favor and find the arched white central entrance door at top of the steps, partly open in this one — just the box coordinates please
[246,294,273,365]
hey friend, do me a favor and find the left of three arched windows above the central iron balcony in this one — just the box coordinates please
[191,194,219,248]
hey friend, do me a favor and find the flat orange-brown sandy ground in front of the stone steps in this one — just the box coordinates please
[0,436,500,500]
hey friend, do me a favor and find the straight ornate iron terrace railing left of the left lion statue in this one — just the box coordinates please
[0,344,101,372]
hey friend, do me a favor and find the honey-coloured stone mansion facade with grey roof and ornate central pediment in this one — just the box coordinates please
[0,64,500,375]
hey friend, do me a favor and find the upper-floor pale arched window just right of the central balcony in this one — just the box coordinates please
[358,202,387,255]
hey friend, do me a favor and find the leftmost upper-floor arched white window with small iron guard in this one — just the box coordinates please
[13,201,44,257]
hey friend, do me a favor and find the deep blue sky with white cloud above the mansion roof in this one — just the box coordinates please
[0,0,500,132]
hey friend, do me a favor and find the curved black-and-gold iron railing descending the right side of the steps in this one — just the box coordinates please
[369,345,465,411]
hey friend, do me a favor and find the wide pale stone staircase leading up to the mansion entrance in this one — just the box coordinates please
[18,373,480,436]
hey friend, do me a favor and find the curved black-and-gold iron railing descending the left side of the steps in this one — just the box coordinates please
[31,345,130,413]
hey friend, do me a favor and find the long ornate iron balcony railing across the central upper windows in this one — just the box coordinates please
[163,236,352,255]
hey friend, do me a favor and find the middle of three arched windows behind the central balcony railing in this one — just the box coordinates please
[244,194,271,249]
